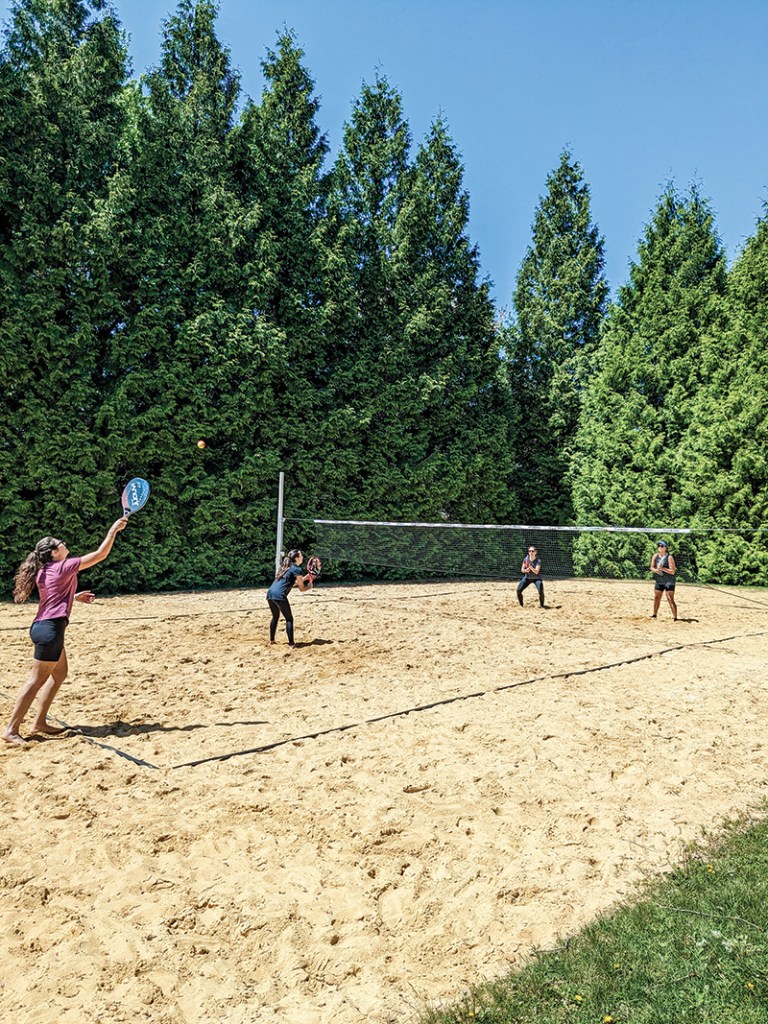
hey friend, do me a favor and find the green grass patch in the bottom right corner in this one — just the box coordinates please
[423,809,768,1024]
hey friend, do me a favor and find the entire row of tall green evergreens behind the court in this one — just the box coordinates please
[0,0,768,591]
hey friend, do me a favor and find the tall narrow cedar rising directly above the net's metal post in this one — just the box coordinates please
[232,33,330,544]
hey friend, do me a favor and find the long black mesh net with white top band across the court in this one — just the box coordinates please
[285,518,768,585]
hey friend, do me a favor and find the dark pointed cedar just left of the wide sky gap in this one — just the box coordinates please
[388,120,515,522]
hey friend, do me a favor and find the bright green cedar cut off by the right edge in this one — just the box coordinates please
[678,217,768,586]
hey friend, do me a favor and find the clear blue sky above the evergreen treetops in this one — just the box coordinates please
[0,0,768,307]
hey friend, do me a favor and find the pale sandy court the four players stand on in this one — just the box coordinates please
[0,582,768,1024]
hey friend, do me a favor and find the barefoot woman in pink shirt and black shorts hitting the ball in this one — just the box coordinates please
[2,517,128,746]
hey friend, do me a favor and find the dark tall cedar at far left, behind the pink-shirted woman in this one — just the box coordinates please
[0,0,126,580]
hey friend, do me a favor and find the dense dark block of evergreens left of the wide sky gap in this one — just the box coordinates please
[0,6,520,590]
